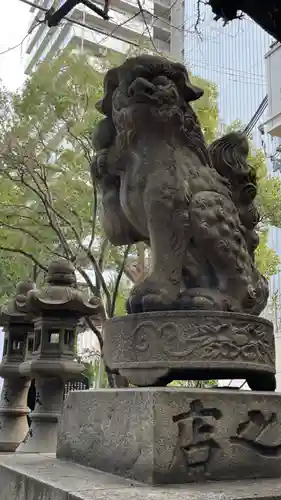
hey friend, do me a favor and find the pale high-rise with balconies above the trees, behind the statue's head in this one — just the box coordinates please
[25,0,184,74]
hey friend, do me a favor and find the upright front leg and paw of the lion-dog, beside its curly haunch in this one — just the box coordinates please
[127,172,187,313]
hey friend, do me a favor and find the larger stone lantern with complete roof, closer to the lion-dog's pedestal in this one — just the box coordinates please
[17,260,100,453]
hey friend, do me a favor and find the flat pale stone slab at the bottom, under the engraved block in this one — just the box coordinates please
[0,454,281,500]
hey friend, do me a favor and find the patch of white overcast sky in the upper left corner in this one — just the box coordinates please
[0,0,31,90]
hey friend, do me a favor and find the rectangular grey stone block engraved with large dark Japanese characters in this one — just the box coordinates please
[57,387,281,484]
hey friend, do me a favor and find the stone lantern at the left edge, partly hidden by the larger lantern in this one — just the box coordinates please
[0,282,35,452]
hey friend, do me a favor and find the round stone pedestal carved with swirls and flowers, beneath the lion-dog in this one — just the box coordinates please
[103,310,275,391]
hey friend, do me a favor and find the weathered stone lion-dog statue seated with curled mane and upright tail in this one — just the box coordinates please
[91,55,268,315]
